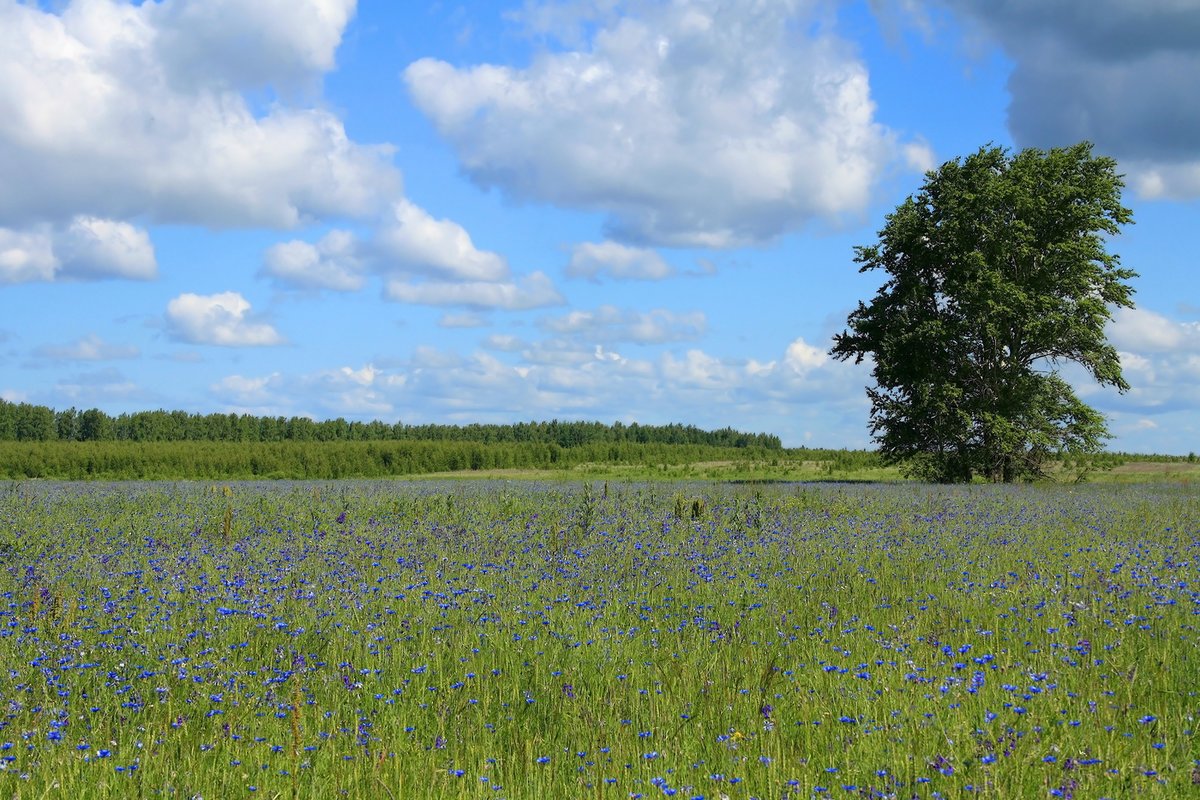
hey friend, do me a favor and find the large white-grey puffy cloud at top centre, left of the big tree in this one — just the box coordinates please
[404,0,912,247]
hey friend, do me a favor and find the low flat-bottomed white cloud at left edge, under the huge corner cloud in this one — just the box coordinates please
[0,217,158,283]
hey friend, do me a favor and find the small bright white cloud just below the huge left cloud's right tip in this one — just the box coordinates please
[374,200,509,281]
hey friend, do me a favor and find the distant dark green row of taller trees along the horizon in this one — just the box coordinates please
[0,399,782,450]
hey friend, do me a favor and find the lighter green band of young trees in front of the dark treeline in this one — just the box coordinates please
[0,441,802,480]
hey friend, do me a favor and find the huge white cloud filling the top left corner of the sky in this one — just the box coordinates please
[0,0,398,229]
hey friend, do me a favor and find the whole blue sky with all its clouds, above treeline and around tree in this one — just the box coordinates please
[0,0,1200,455]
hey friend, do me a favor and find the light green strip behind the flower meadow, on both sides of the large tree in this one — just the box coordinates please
[0,440,1200,483]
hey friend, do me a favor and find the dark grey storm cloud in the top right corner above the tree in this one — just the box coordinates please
[921,0,1200,198]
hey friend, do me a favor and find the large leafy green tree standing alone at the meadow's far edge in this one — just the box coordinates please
[832,143,1135,482]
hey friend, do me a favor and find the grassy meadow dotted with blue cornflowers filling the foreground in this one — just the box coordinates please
[0,481,1200,800]
